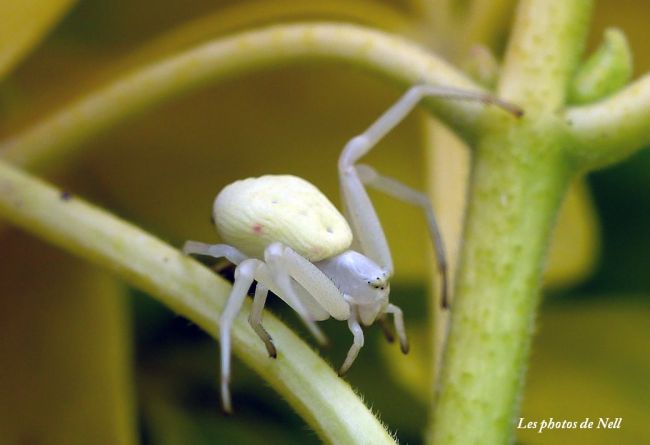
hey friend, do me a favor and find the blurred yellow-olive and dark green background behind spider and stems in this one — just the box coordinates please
[0,0,650,445]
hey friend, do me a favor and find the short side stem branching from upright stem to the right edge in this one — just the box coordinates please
[565,75,650,169]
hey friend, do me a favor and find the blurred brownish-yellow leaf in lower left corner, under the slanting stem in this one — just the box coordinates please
[0,231,136,445]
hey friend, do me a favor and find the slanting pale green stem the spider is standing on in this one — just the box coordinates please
[0,162,394,444]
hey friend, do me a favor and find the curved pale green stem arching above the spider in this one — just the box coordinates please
[0,24,484,172]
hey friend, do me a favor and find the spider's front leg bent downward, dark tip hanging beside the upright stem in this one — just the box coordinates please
[356,164,449,308]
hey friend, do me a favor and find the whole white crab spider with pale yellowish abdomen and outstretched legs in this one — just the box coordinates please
[183,85,521,412]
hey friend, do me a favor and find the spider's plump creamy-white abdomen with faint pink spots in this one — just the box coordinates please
[213,175,352,261]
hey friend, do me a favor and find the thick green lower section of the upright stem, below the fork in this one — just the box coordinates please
[433,119,570,444]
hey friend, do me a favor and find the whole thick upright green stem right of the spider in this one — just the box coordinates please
[429,0,590,445]
